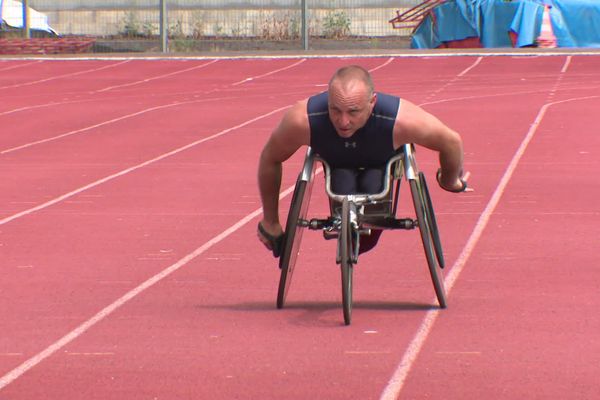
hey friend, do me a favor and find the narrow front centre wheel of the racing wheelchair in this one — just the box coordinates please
[338,199,355,325]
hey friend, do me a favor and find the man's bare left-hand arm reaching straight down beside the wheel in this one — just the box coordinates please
[258,101,310,244]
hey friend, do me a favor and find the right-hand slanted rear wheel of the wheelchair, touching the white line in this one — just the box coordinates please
[409,179,447,308]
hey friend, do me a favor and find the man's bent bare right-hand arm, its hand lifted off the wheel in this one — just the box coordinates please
[394,99,463,190]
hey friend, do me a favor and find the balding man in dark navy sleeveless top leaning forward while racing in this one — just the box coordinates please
[257,65,467,257]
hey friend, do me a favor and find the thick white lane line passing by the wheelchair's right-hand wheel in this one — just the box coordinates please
[380,60,600,400]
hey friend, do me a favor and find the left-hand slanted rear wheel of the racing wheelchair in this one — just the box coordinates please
[277,175,313,308]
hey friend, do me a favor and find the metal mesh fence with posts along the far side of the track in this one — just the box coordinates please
[0,0,421,52]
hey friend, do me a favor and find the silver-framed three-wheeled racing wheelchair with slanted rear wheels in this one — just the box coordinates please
[277,144,447,325]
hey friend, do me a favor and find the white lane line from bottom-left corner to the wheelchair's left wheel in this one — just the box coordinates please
[0,172,295,390]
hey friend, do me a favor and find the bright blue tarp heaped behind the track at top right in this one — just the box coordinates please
[412,0,600,48]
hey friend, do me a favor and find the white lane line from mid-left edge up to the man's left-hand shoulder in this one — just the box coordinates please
[0,106,290,225]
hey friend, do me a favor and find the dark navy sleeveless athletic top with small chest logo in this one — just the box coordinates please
[307,92,400,168]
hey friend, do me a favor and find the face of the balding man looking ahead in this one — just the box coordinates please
[329,81,377,138]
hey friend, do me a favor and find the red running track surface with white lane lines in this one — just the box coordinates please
[0,54,600,400]
